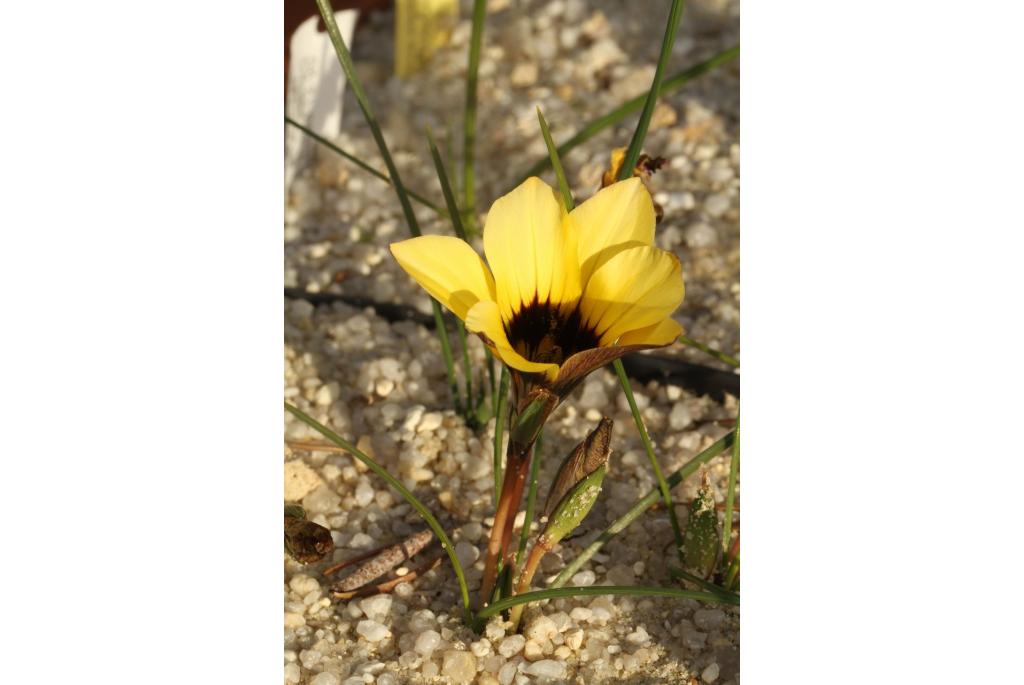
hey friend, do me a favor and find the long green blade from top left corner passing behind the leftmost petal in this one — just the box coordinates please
[316,0,462,414]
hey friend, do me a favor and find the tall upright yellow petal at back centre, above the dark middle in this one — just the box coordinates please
[483,177,580,320]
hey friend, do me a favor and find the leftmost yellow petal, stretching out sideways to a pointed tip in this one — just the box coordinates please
[391,236,495,319]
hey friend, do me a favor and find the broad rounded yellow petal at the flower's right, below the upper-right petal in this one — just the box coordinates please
[580,246,683,345]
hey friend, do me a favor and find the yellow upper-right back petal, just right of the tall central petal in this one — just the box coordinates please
[569,178,654,287]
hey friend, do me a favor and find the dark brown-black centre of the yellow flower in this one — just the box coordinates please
[505,296,599,365]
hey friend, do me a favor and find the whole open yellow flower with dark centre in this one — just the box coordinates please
[391,178,683,396]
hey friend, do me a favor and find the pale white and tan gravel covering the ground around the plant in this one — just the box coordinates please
[284,0,739,685]
